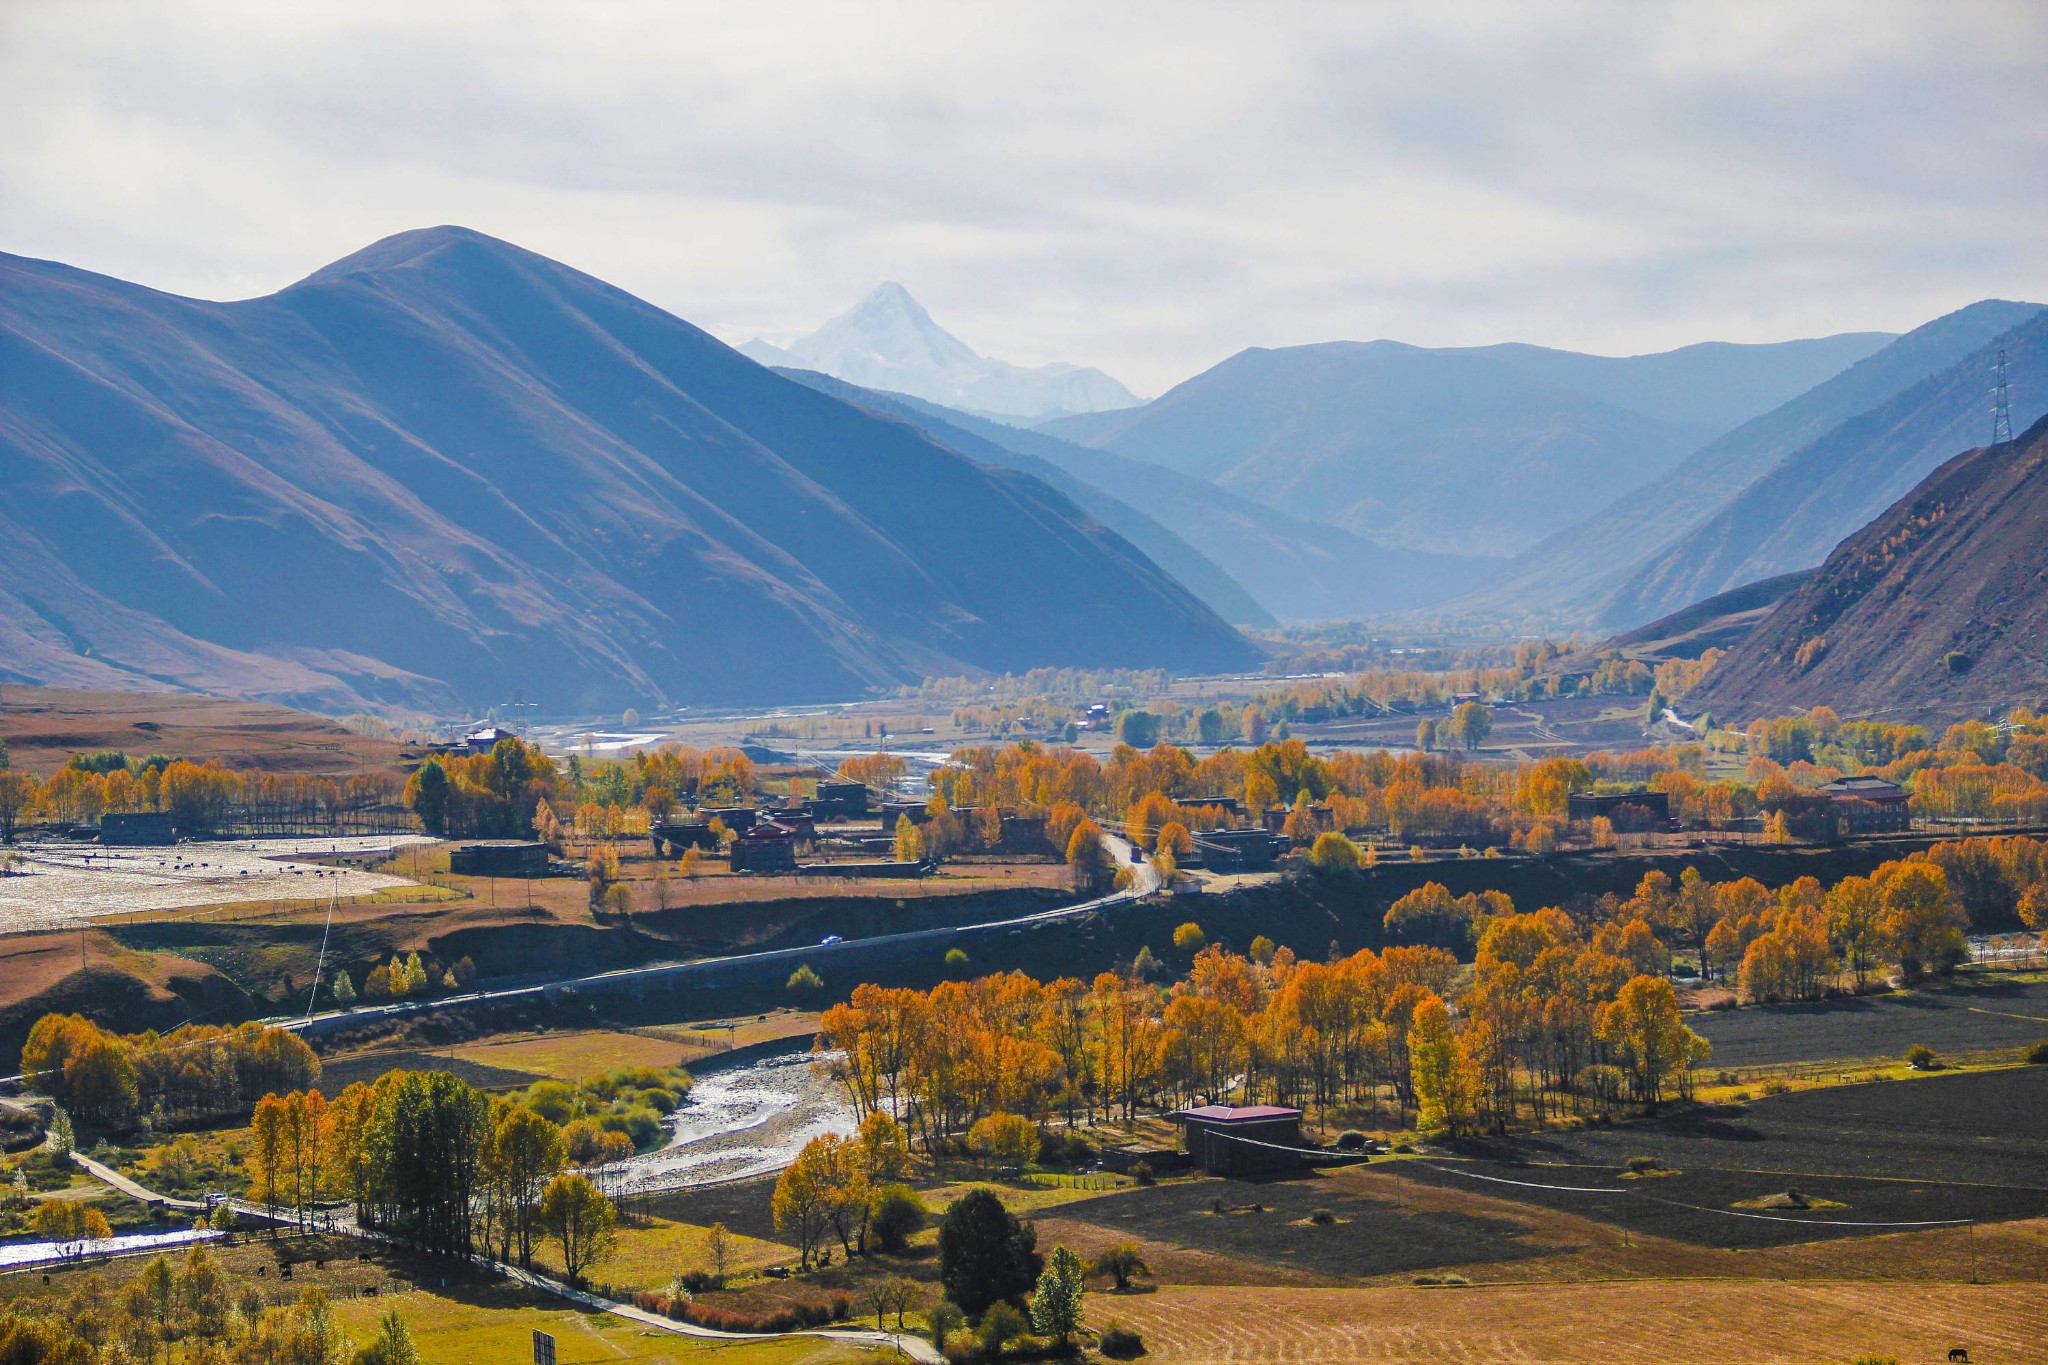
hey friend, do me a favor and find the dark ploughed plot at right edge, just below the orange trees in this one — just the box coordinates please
[1688,976,2048,1068]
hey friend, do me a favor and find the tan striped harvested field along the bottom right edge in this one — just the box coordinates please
[1087,1281,2048,1365]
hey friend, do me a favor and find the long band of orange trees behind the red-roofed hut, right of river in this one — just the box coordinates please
[819,933,1706,1150]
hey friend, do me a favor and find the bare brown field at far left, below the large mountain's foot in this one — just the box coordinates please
[0,686,401,778]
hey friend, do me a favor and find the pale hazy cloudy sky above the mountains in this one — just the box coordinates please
[0,0,2048,393]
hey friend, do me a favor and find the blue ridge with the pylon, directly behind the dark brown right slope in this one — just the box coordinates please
[1599,309,2048,626]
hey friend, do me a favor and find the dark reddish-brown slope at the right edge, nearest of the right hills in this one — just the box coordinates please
[1686,417,2048,722]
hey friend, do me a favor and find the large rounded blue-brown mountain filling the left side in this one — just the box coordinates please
[0,227,1255,712]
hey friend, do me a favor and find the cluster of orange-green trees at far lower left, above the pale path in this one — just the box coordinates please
[20,1015,319,1130]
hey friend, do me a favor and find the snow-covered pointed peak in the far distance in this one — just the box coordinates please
[739,282,1139,422]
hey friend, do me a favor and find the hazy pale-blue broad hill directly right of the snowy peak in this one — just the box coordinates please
[1040,334,1890,557]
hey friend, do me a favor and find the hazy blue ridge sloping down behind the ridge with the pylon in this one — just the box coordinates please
[1454,299,2040,616]
